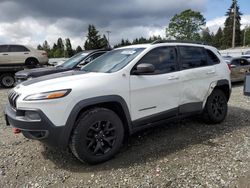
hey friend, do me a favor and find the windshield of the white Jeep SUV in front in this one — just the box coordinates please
[81,48,145,73]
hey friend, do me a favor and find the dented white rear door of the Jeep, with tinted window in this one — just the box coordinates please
[179,46,219,113]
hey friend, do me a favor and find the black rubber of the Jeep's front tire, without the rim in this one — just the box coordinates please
[71,109,124,164]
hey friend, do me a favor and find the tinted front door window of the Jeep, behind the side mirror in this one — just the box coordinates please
[137,47,177,74]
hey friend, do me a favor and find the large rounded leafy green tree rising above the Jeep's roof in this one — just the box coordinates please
[166,9,206,40]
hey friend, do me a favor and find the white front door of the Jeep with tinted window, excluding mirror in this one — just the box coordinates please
[130,46,180,124]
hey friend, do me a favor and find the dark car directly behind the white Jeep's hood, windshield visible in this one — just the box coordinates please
[15,50,107,84]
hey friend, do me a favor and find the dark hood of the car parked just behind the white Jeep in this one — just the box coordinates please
[15,67,69,79]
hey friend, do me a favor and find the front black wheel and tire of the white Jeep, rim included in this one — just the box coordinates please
[70,108,124,164]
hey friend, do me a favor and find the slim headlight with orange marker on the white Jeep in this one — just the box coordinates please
[24,89,71,101]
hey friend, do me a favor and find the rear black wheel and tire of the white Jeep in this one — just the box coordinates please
[205,89,228,124]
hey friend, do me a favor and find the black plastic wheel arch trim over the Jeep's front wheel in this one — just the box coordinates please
[60,95,131,146]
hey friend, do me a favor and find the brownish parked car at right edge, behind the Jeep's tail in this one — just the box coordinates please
[228,57,250,82]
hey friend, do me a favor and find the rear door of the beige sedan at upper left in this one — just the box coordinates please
[9,45,30,64]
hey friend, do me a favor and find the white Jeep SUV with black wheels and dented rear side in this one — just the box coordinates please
[5,41,231,163]
